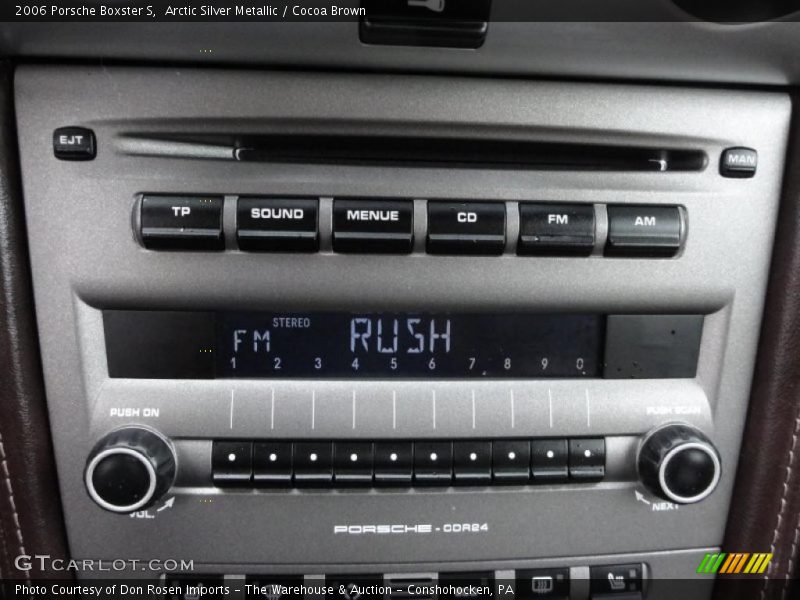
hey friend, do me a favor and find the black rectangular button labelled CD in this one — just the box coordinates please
[428,202,506,256]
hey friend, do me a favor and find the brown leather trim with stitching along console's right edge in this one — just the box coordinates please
[715,95,800,600]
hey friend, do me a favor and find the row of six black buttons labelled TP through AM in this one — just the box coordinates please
[140,194,685,257]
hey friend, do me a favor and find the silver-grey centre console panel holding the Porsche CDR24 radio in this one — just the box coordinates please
[16,66,790,598]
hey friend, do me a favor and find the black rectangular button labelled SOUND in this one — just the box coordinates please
[236,198,319,252]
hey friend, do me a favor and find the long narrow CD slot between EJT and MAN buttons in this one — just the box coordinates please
[117,131,708,172]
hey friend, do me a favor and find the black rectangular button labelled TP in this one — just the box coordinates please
[141,195,225,250]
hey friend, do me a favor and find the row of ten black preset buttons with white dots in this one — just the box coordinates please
[212,438,605,487]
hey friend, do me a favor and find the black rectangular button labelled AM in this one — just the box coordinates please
[606,206,683,258]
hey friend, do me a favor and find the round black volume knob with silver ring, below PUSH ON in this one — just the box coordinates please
[84,427,175,513]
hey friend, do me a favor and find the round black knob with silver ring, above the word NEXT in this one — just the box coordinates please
[637,424,722,504]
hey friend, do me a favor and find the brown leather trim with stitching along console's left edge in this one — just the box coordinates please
[0,63,67,580]
